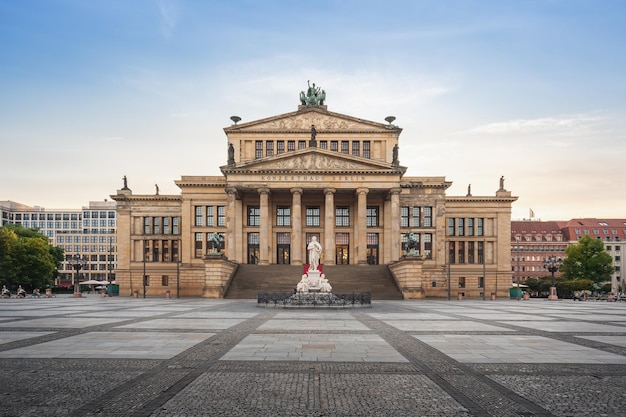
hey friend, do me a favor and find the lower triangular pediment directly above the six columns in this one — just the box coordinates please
[221,148,406,174]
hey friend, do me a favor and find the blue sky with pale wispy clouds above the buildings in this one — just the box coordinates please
[0,0,626,220]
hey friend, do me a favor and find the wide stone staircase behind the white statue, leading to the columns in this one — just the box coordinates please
[224,264,402,300]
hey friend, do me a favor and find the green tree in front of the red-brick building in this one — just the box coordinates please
[561,235,615,284]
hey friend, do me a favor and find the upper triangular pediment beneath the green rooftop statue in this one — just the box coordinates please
[224,106,401,133]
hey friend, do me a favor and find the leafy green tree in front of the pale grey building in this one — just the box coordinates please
[0,224,63,288]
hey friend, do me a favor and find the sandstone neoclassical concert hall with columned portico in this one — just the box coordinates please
[111,87,517,298]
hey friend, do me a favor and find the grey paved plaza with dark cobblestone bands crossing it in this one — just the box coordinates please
[0,295,626,417]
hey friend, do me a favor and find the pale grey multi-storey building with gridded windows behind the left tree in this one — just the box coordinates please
[0,201,117,286]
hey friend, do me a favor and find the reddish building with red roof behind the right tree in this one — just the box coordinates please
[511,218,626,292]
